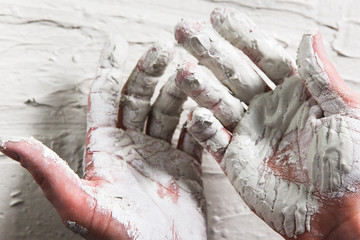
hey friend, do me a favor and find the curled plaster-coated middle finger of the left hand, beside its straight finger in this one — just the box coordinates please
[117,43,174,131]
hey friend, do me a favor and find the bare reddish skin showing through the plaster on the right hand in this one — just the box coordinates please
[207,33,360,240]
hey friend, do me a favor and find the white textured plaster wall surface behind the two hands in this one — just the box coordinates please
[0,0,360,240]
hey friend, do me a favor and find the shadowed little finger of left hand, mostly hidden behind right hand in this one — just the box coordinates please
[177,126,203,163]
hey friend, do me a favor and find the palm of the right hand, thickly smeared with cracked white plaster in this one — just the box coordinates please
[223,74,359,239]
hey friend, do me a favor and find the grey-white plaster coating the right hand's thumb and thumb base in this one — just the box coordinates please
[297,32,358,192]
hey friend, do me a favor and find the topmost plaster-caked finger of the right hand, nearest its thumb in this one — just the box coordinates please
[210,8,296,84]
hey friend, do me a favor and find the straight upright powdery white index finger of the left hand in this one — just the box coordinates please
[87,35,128,129]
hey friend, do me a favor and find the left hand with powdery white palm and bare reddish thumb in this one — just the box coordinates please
[1,35,206,239]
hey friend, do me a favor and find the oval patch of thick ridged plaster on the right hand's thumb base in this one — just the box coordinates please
[307,115,354,192]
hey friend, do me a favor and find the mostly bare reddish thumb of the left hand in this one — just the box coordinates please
[1,142,130,239]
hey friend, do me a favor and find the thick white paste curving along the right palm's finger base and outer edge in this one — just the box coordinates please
[221,76,318,237]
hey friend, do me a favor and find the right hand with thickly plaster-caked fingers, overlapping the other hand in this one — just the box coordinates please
[175,9,360,239]
